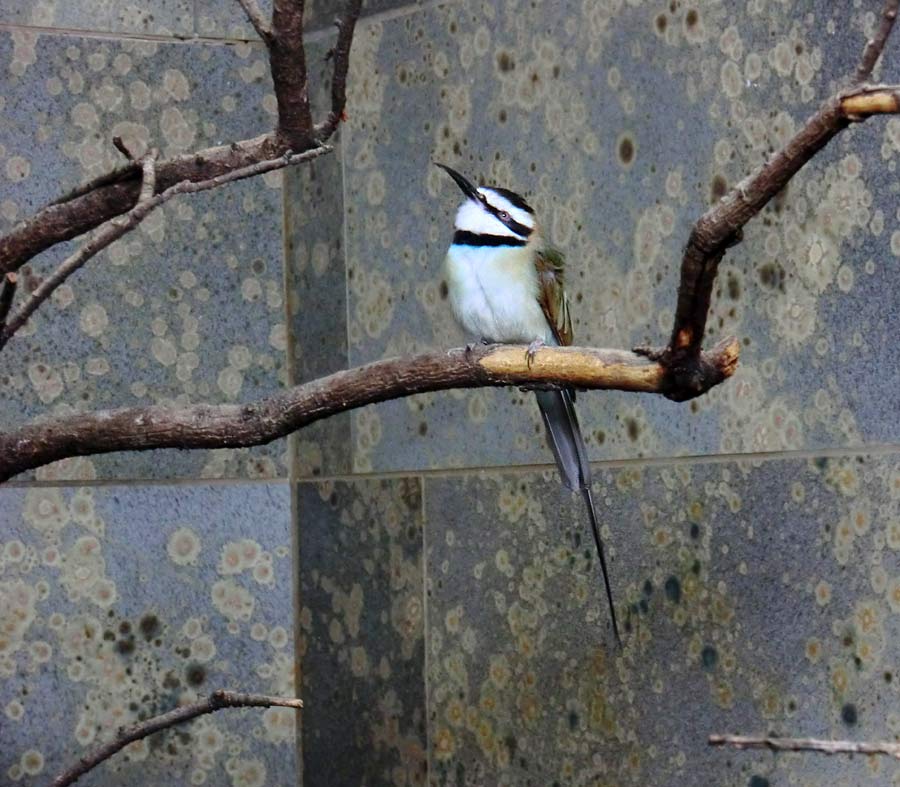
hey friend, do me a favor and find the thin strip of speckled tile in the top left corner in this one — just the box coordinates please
[0,0,194,37]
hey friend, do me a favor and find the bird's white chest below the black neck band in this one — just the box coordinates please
[446,245,553,344]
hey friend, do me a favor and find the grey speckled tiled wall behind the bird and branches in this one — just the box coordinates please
[0,0,900,787]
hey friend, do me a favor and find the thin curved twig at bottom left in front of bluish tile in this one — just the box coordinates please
[53,689,303,787]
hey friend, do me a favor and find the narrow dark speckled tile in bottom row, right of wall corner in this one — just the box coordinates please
[297,479,426,787]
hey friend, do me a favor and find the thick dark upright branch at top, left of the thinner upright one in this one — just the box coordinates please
[267,0,313,152]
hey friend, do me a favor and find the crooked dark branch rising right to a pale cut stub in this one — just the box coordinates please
[668,86,900,359]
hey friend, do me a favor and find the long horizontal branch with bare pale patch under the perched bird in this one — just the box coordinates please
[0,339,739,481]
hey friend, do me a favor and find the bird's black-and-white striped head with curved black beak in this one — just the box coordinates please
[437,164,537,246]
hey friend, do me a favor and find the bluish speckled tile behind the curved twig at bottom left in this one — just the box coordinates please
[0,484,296,787]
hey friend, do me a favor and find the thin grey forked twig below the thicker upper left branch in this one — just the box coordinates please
[0,145,332,350]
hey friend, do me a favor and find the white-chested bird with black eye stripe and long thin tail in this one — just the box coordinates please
[434,162,621,644]
